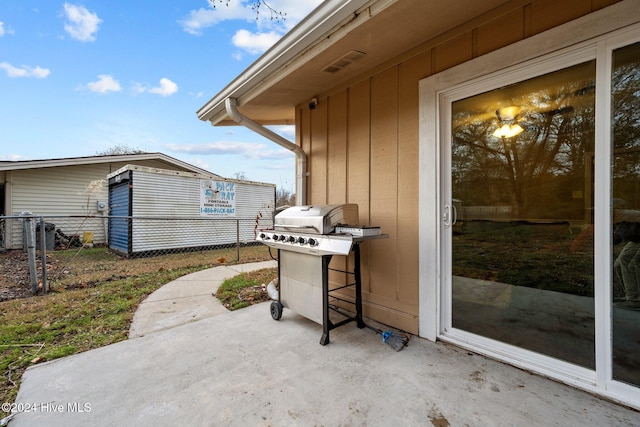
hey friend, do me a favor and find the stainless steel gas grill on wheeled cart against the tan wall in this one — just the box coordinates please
[256,204,388,345]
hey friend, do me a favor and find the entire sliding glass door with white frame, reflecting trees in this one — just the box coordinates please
[420,18,640,408]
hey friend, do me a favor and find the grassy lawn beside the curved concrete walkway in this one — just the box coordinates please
[0,245,277,418]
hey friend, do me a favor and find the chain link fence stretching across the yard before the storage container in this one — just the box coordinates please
[0,213,275,300]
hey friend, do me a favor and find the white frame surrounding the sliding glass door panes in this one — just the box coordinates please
[419,0,640,408]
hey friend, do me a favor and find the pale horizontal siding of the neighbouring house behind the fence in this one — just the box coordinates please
[5,160,198,249]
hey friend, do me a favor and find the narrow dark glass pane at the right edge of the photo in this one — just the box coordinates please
[611,43,640,385]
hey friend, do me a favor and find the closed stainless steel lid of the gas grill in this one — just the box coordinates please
[273,203,358,234]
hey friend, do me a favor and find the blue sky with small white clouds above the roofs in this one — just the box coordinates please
[0,0,321,190]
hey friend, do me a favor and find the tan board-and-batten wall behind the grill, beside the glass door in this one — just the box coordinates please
[296,0,618,334]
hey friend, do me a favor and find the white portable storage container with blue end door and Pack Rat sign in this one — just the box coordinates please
[108,165,276,256]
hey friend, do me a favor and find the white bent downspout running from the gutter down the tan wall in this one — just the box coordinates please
[224,98,307,206]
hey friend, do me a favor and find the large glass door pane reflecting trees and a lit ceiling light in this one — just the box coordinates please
[450,61,596,369]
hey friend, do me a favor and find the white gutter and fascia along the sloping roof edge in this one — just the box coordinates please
[197,0,376,125]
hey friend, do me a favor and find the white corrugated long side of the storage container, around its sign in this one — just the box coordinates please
[125,170,275,253]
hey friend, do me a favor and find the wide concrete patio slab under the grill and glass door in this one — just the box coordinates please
[10,303,640,427]
